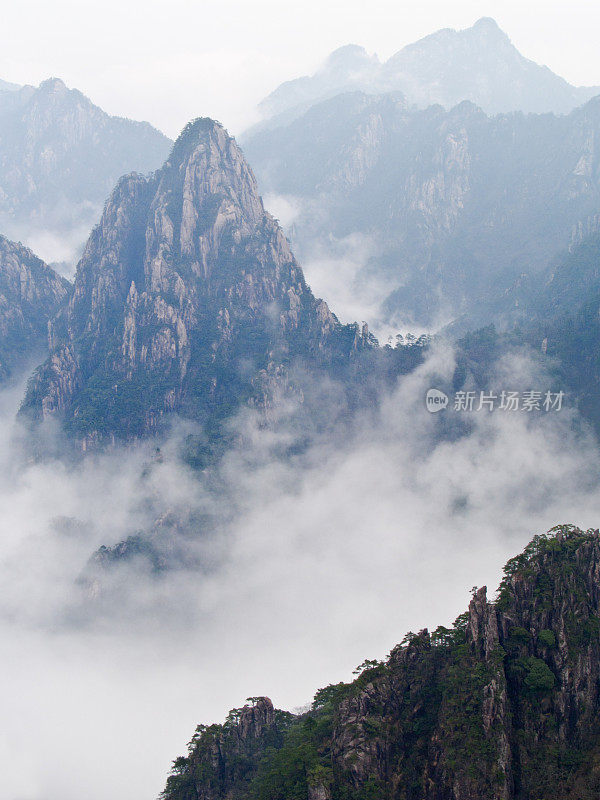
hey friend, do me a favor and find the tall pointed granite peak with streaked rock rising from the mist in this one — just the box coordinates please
[25,119,370,442]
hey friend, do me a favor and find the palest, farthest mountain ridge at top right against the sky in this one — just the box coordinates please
[259,17,600,129]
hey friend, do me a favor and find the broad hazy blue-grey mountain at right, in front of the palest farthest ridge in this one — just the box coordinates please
[244,93,600,325]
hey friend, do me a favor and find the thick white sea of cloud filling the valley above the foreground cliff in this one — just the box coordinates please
[0,345,600,800]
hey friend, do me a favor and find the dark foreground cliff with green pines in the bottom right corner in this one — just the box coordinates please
[163,526,600,800]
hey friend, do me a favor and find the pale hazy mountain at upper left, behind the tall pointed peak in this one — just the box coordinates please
[0,78,171,256]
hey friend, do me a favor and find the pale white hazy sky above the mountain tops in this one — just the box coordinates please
[0,0,600,136]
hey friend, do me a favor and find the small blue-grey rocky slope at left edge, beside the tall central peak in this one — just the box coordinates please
[0,236,71,380]
